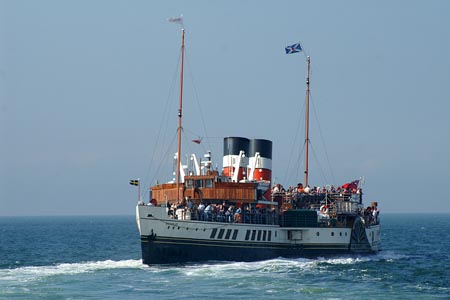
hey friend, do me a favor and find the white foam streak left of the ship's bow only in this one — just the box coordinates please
[0,259,147,282]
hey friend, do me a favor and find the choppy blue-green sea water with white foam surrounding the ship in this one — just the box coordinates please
[0,214,450,299]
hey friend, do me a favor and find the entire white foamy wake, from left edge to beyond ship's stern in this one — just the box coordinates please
[0,251,409,282]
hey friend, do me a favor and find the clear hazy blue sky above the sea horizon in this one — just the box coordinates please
[0,0,450,216]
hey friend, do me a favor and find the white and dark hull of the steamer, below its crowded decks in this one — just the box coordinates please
[136,205,380,264]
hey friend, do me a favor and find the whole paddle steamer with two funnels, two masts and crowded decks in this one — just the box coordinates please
[134,23,380,264]
